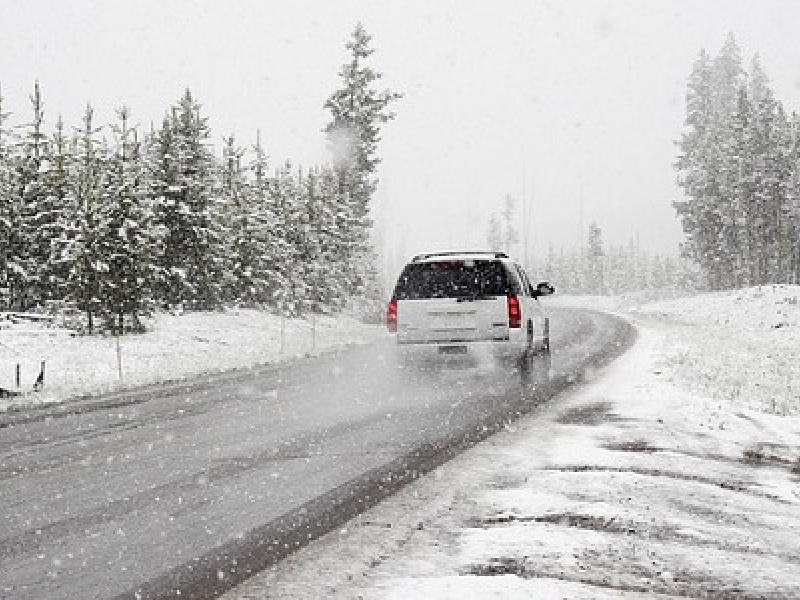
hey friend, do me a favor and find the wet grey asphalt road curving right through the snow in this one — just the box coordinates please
[0,309,632,600]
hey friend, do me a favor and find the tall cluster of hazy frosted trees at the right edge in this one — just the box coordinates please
[675,35,800,290]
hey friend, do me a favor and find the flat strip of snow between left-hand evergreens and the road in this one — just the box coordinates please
[0,309,385,412]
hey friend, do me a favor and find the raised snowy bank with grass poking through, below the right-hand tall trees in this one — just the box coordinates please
[631,285,800,415]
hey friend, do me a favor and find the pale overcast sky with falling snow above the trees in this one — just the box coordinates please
[0,0,800,276]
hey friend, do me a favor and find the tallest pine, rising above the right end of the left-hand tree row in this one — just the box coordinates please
[324,23,402,295]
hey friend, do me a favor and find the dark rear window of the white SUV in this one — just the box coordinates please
[394,260,509,300]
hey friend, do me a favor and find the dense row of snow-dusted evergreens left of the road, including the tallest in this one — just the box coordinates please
[0,25,399,331]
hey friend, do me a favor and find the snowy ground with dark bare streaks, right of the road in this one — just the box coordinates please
[226,286,800,600]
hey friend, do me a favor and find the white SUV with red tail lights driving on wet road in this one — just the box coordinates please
[387,252,555,365]
